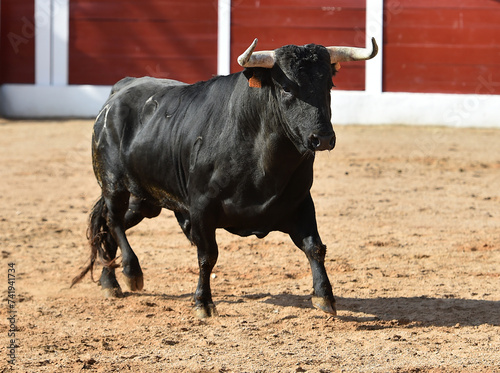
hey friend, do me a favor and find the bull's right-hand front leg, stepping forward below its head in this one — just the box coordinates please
[289,195,337,315]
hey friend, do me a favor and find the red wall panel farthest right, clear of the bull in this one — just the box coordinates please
[383,0,500,94]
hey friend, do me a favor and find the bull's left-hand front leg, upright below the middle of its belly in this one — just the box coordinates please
[191,222,219,319]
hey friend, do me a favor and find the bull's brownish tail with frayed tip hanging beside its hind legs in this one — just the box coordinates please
[70,196,116,287]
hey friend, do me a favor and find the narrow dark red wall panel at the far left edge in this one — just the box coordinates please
[0,0,35,84]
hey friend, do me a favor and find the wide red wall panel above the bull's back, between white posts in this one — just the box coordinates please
[69,0,217,85]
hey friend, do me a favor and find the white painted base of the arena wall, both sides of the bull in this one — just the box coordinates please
[0,84,500,128]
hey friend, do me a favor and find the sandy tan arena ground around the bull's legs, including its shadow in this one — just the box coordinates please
[0,119,500,373]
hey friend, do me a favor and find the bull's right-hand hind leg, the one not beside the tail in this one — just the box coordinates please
[104,191,144,291]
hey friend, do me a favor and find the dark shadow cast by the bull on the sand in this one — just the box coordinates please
[260,294,500,326]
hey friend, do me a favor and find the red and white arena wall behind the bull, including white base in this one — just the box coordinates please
[0,0,500,127]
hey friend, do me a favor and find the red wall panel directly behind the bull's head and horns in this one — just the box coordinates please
[231,0,366,90]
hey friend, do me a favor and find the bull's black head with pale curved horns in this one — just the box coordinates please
[238,39,378,151]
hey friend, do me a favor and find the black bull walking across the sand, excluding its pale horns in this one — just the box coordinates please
[73,40,376,317]
